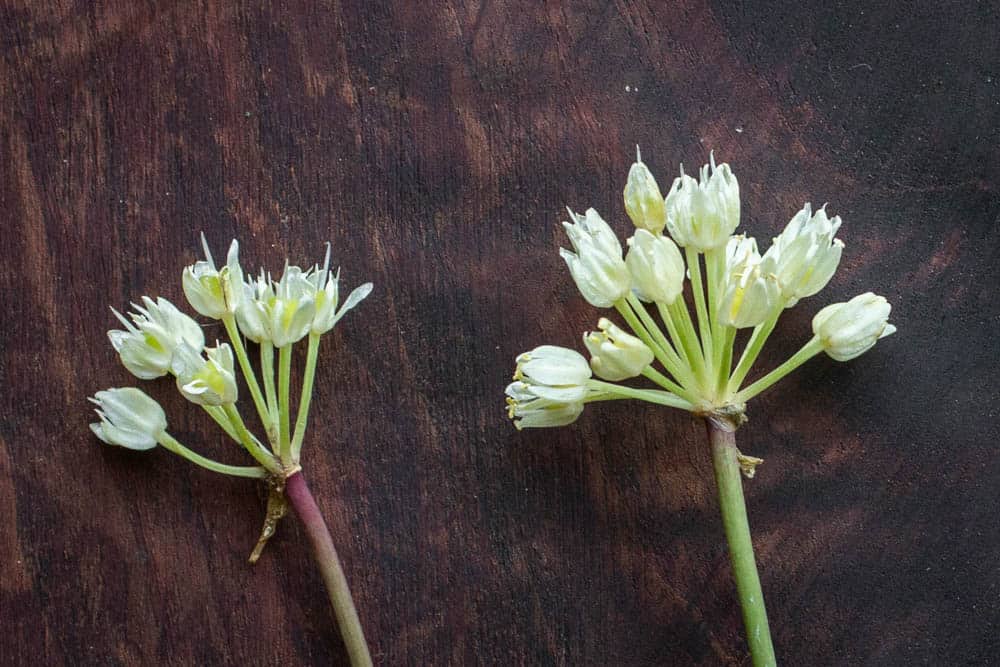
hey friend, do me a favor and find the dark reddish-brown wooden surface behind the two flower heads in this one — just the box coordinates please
[0,0,1000,665]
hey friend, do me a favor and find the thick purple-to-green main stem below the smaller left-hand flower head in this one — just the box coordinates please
[285,472,372,667]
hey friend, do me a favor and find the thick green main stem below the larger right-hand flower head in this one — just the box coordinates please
[705,417,777,667]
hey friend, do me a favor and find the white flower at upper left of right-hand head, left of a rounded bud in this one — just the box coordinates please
[559,209,631,308]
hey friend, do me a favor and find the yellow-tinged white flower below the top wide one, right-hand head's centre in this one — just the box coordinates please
[718,236,780,329]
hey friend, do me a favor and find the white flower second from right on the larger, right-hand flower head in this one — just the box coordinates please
[765,204,844,308]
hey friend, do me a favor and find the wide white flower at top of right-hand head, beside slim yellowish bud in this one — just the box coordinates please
[666,155,740,252]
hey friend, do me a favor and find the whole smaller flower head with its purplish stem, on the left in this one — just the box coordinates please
[90,235,376,665]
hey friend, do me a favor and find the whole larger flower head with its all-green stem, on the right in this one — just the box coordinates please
[505,150,896,666]
